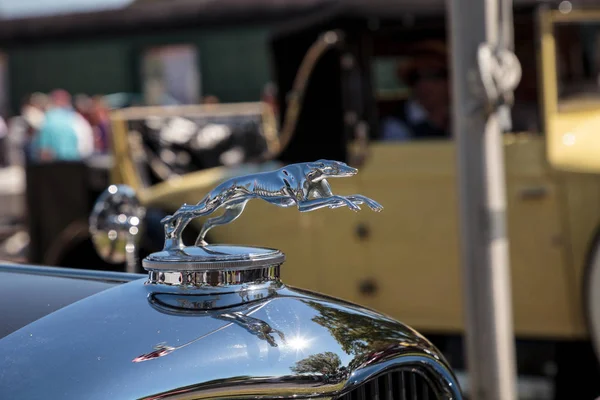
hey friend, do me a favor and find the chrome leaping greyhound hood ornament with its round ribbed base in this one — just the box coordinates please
[142,160,383,287]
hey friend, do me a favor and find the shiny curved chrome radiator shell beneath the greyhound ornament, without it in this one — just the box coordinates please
[0,279,456,400]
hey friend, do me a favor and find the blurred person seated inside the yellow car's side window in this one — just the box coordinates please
[382,40,450,140]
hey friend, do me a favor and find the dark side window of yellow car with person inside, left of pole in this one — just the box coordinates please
[371,36,451,142]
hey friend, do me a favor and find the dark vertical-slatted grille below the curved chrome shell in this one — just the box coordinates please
[338,371,441,400]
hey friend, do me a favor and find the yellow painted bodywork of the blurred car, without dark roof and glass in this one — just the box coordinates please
[112,10,600,338]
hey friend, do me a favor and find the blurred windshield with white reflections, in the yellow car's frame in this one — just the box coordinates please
[119,103,273,186]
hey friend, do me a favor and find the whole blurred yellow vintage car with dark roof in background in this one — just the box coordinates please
[89,1,600,396]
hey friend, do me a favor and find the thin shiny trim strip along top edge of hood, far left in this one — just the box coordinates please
[0,264,147,283]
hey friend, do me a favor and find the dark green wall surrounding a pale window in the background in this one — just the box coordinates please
[5,26,270,111]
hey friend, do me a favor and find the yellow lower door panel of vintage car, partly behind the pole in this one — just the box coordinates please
[359,28,573,335]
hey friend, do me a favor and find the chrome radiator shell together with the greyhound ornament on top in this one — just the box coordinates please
[0,160,461,400]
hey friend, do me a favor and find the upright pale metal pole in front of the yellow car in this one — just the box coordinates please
[447,0,516,400]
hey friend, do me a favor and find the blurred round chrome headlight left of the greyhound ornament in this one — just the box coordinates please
[90,185,145,273]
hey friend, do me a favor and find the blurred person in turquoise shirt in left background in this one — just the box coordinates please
[33,90,81,162]
